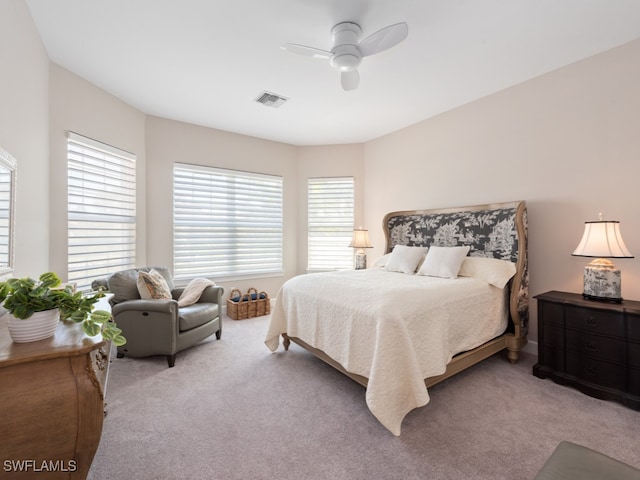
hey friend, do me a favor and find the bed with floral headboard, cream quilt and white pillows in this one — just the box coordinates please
[265,201,529,435]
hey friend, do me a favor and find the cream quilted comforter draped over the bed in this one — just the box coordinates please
[265,269,507,435]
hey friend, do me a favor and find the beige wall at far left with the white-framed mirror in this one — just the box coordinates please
[0,1,49,276]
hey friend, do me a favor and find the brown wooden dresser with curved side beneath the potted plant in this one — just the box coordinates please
[0,318,110,480]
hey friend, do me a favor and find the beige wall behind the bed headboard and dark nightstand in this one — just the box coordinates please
[364,41,640,340]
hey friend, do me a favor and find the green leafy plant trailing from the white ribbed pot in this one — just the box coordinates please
[0,272,127,346]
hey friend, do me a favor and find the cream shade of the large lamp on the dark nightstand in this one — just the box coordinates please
[571,220,633,258]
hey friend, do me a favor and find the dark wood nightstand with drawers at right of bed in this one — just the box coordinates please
[533,291,640,410]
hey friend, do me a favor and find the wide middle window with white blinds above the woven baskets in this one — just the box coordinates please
[173,163,282,280]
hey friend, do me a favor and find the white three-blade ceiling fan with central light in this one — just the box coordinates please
[282,22,409,90]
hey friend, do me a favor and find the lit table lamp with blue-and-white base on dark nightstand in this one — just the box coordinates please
[571,214,633,303]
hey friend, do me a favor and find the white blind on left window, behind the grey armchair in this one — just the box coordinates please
[67,132,136,290]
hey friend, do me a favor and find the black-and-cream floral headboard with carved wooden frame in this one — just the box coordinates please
[383,201,529,338]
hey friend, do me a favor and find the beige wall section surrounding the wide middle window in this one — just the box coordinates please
[146,117,298,296]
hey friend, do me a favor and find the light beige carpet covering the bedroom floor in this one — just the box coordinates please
[89,317,640,480]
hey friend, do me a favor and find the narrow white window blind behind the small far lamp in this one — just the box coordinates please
[307,177,354,271]
